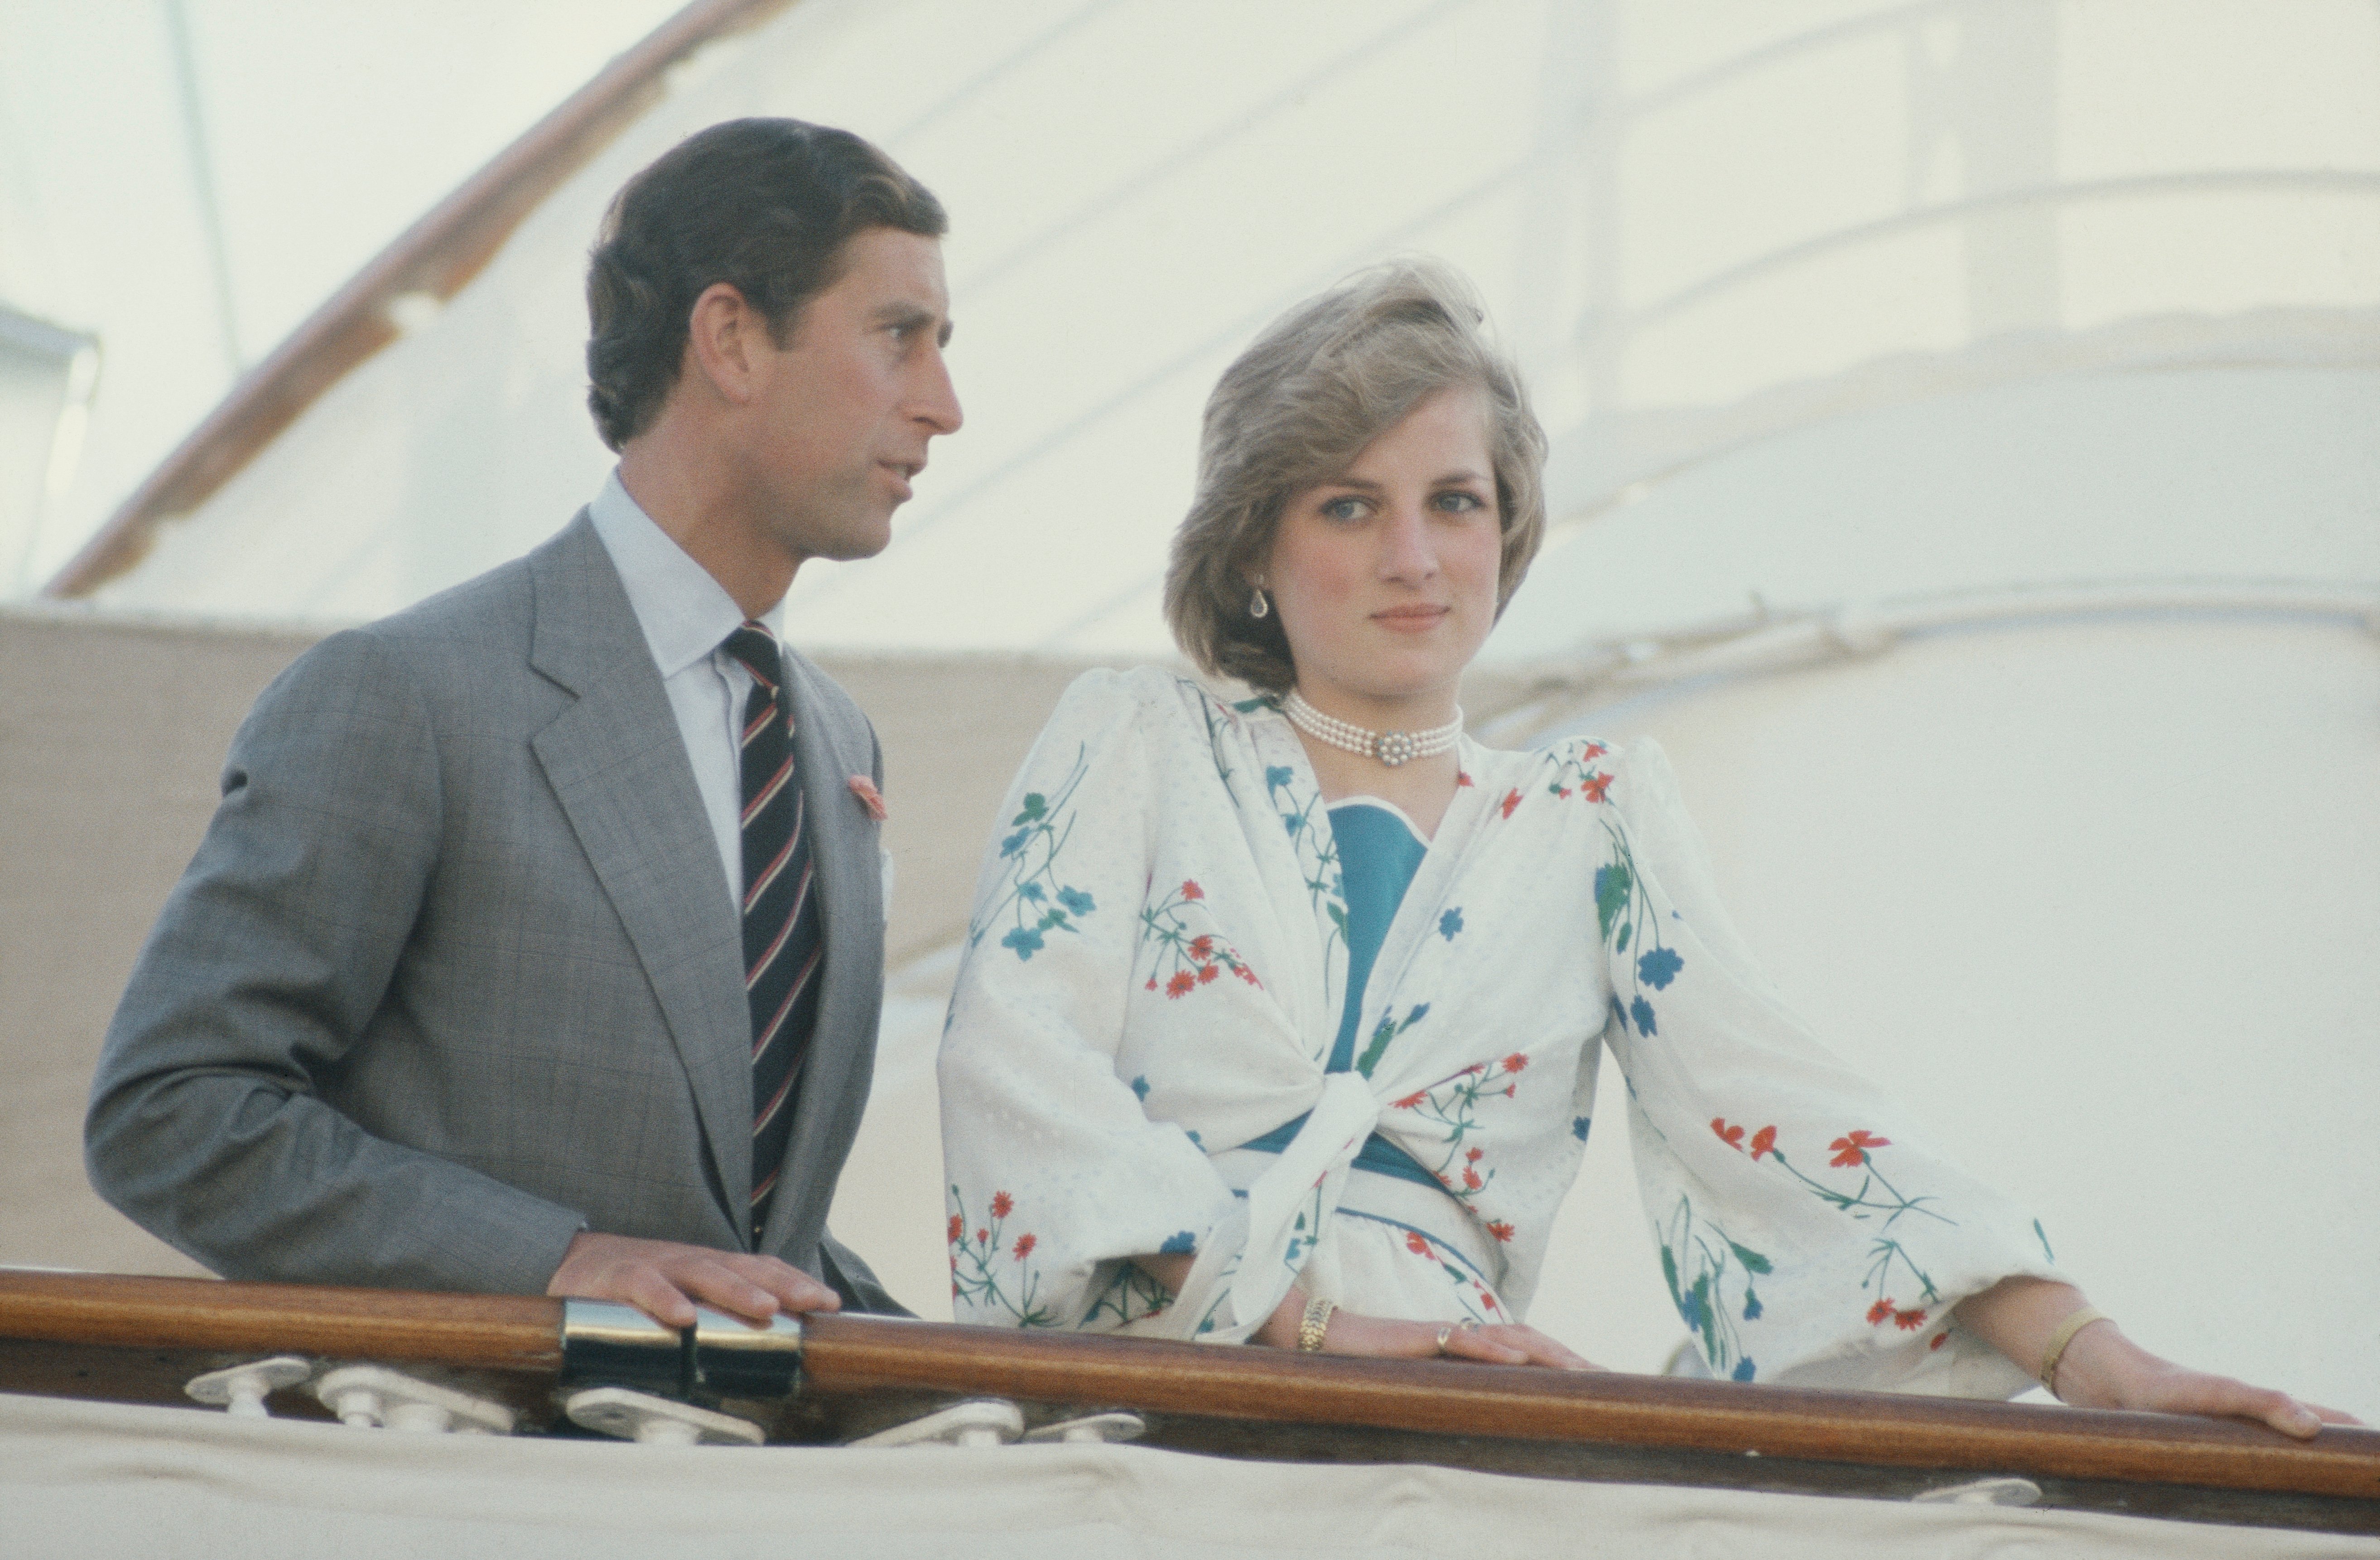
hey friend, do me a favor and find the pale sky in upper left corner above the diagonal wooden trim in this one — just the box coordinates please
[0,0,681,595]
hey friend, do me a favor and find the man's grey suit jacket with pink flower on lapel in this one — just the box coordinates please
[86,512,890,1310]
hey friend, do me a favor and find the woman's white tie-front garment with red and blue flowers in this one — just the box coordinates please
[940,669,2056,1396]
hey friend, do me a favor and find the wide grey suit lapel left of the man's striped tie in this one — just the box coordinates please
[528,512,752,1229]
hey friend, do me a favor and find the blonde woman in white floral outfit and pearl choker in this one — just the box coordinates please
[940,264,2327,1434]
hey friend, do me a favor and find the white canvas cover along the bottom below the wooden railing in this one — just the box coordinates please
[0,1396,2380,1560]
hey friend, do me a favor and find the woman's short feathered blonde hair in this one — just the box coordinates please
[1166,260,1545,693]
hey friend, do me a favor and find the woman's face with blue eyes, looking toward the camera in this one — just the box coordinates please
[1262,388,1504,726]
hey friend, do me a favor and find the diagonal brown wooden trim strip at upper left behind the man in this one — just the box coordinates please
[40,0,793,600]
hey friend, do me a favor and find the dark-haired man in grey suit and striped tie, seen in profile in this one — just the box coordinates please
[86,119,959,1327]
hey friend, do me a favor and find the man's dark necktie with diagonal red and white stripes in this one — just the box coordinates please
[721,622,826,1246]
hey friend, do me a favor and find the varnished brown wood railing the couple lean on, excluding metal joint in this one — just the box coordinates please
[0,1272,2380,1529]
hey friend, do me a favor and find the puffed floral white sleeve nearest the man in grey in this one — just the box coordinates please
[940,671,1233,1327]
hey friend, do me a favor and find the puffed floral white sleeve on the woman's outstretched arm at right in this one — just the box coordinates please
[1595,741,2059,1398]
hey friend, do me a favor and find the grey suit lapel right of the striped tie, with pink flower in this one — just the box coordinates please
[759,652,883,1255]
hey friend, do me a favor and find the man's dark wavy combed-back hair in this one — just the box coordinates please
[588,119,949,450]
